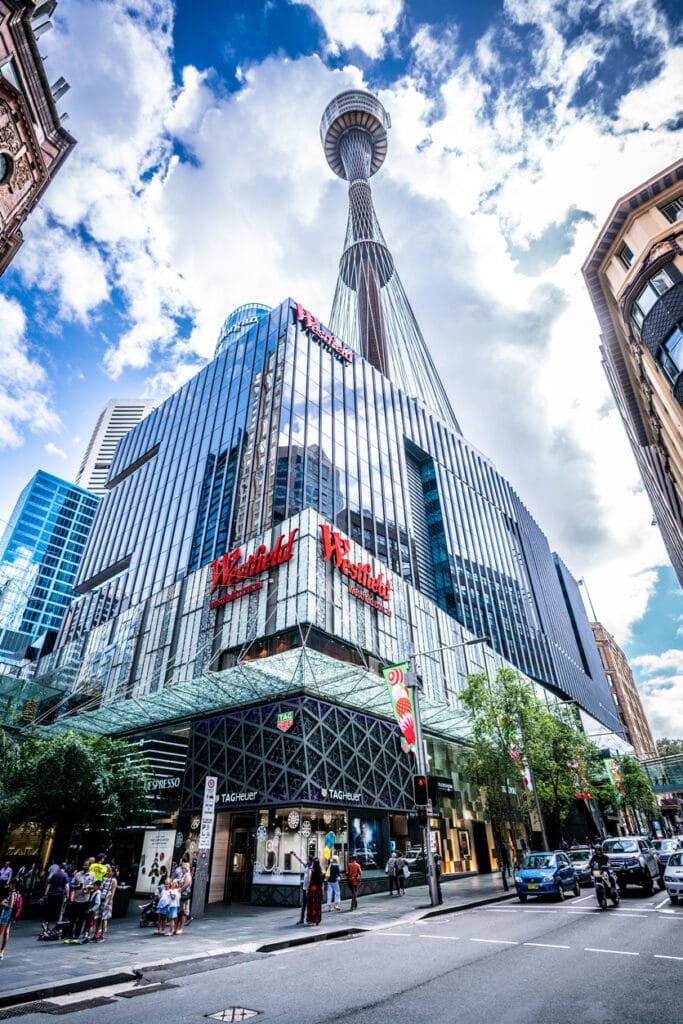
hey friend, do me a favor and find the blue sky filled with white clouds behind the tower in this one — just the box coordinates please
[0,0,683,736]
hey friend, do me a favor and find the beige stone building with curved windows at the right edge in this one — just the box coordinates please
[583,160,683,584]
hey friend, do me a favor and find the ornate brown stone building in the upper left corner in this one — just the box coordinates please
[0,0,76,273]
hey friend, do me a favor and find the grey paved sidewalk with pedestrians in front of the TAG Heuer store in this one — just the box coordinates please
[0,874,514,1007]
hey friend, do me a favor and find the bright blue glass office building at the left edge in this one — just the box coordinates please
[0,470,99,653]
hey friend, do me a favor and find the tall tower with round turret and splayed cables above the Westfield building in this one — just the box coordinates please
[321,89,460,430]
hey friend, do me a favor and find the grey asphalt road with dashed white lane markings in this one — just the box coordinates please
[7,890,683,1024]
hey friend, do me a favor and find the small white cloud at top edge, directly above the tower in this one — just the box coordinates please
[291,0,403,58]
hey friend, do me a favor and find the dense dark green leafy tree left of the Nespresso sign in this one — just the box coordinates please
[12,731,148,857]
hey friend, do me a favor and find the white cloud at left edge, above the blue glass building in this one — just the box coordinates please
[0,295,59,447]
